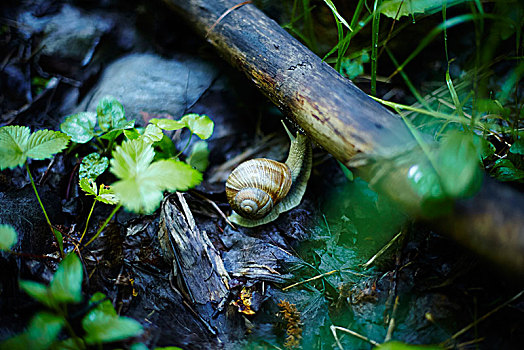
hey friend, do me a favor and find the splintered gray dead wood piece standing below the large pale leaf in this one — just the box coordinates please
[158,193,229,305]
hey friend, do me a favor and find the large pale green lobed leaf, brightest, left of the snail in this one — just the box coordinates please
[110,140,202,213]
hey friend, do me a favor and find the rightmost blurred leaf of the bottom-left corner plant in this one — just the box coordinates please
[82,308,143,344]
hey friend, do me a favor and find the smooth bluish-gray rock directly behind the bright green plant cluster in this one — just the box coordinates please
[80,54,218,124]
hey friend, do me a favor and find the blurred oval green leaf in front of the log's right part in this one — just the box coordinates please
[437,131,482,197]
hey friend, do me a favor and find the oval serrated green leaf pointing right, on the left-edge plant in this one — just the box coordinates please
[26,130,69,160]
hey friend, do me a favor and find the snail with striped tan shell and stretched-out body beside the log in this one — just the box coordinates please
[226,125,312,227]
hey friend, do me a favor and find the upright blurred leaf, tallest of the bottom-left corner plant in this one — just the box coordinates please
[49,253,84,303]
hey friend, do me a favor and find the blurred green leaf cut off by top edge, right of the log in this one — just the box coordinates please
[380,0,467,18]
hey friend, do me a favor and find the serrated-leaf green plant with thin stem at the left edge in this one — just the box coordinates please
[0,126,69,256]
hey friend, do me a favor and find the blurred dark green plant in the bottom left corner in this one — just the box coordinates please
[0,253,143,350]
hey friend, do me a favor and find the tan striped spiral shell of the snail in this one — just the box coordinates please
[226,158,291,219]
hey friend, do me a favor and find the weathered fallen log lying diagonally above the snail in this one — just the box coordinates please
[164,0,524,274]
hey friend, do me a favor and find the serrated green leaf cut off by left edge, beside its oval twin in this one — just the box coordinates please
[0,125,30,170]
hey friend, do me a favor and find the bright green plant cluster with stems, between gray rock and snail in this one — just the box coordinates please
[60,96,214,246]
